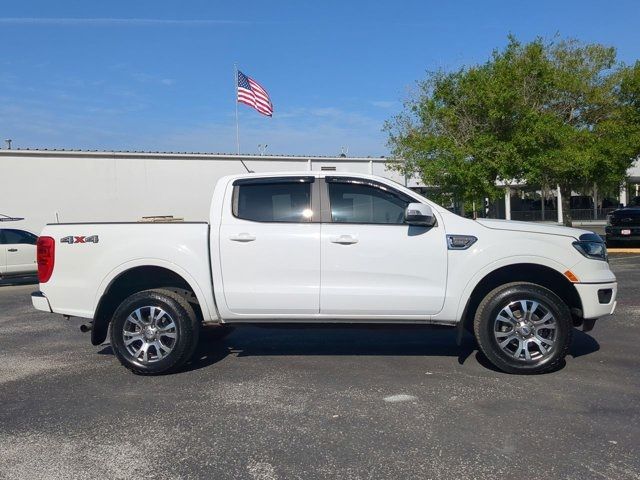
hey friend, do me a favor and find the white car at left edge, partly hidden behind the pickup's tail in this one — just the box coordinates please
[0,227,38,278]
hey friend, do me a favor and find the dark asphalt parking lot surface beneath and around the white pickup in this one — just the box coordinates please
[0,255,640,479]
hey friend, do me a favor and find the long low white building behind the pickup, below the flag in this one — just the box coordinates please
[0,150,419,233]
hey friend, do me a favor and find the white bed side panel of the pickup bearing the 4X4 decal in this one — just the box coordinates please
[40,223,216,320]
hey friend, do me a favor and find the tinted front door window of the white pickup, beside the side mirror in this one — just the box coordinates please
[327,181,411,225]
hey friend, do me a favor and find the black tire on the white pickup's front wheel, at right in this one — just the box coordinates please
[473,282,573,374]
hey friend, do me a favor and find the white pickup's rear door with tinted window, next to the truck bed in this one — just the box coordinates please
[220,176,320,319]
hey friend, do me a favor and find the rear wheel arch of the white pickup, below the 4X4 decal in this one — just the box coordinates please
[91,261,215,345]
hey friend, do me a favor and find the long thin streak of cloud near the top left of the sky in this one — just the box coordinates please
[0,17,252,27]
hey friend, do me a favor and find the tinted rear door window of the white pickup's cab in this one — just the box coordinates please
[233,177,313,223]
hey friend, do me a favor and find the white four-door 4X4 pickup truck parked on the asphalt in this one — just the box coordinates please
[32,172,617,374]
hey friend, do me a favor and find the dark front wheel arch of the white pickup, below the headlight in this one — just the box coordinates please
[460,262,582,330]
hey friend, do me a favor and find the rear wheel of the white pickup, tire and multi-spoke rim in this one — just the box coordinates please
[111,289,200,375]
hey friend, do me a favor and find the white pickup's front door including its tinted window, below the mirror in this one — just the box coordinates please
[320,177,447,319]
